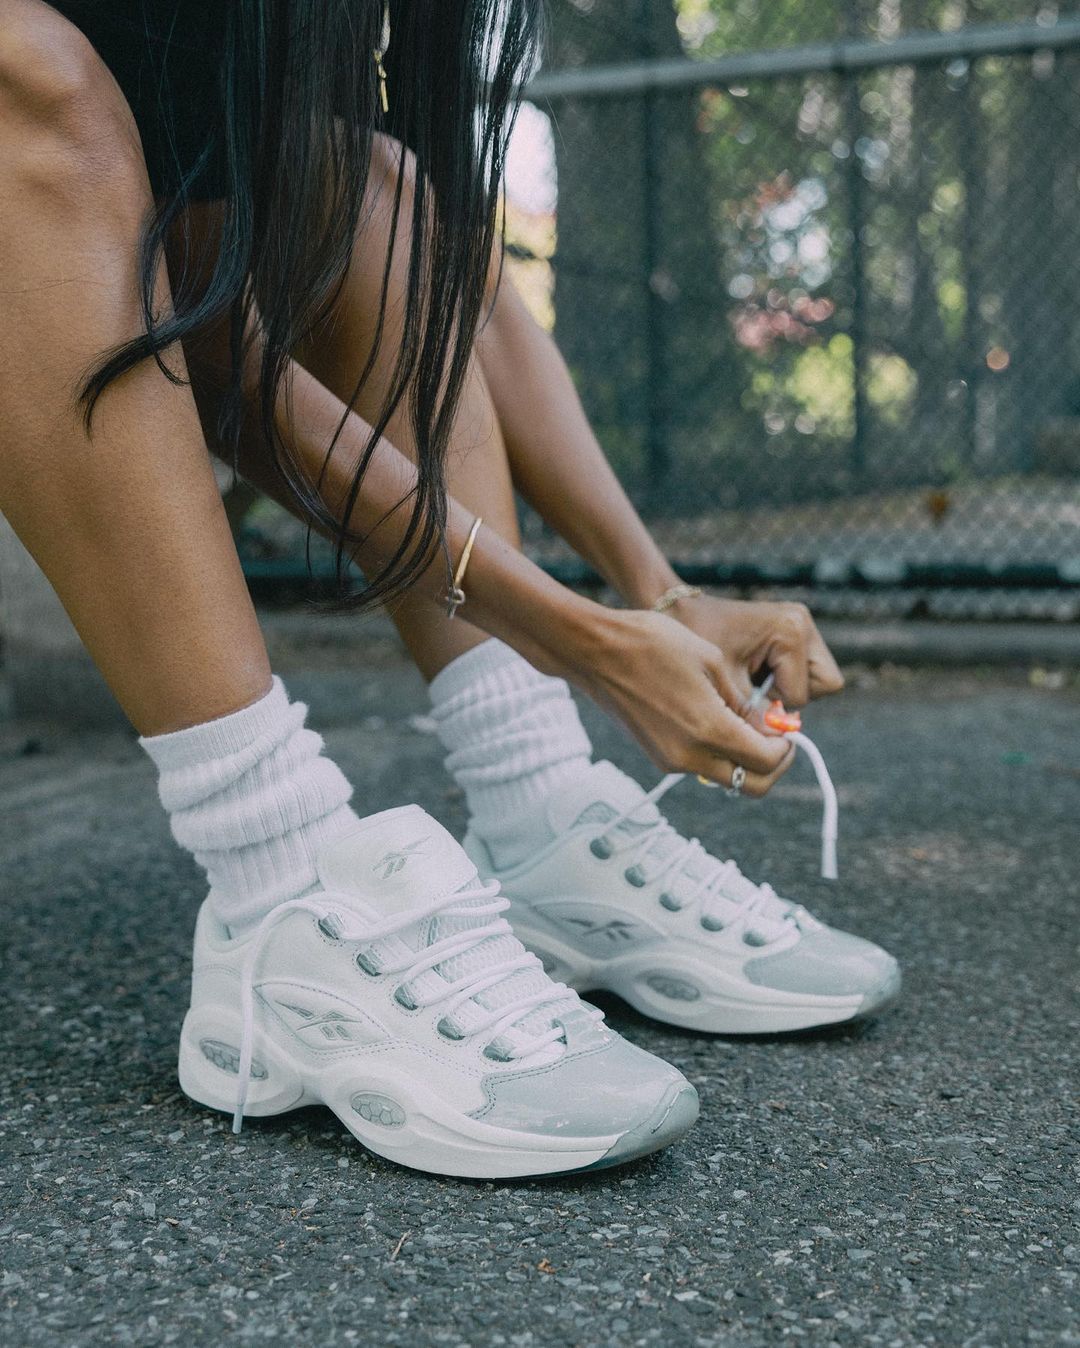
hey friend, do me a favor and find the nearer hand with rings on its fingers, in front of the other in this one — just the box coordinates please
[566,609,794,795]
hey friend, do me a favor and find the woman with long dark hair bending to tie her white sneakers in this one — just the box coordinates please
[0,0,895,1177]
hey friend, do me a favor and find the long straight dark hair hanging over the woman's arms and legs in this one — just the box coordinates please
[84,0,539,605]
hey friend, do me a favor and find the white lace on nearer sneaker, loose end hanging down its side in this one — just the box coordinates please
[225,882,582,1134]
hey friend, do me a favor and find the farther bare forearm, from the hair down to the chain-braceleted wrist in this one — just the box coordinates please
[477,276,678,608]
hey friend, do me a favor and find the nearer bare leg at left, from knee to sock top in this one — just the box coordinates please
[0,0,270,735]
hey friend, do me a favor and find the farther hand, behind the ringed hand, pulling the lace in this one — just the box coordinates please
[670,594,844,709]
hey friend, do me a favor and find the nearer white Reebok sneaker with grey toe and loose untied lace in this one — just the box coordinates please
[179,805,697,1178]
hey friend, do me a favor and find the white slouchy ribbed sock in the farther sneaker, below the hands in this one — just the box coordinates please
[430,640,592,869]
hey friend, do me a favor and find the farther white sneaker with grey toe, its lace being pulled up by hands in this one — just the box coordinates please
[465,763,901,1034]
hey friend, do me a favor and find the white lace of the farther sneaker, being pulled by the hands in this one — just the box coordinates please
[591,722,839,940]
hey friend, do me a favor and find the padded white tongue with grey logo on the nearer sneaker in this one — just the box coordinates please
[316,805,476,917]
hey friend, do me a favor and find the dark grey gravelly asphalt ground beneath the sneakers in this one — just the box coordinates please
[0,634,1080,1348]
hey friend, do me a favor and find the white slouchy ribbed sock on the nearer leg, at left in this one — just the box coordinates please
[139,678,357,934]
